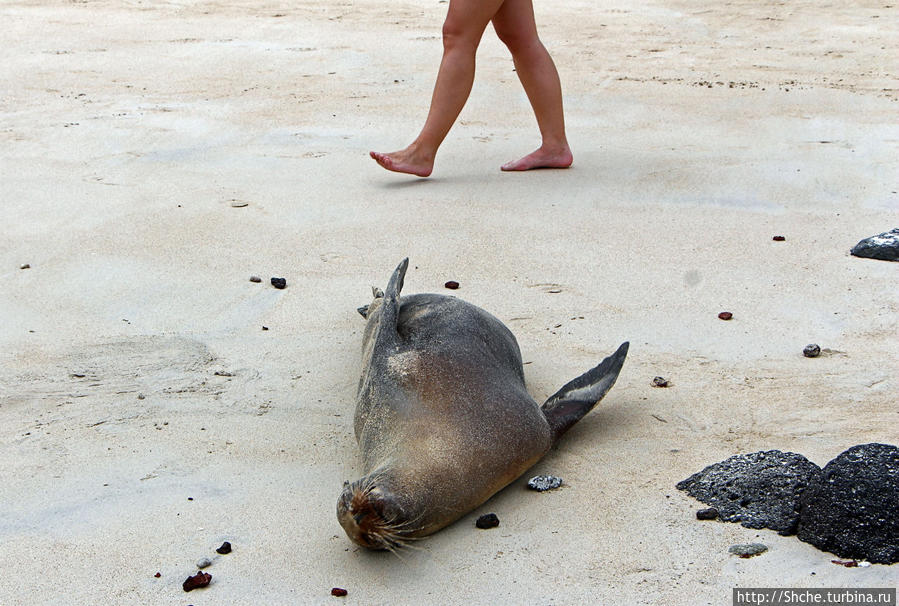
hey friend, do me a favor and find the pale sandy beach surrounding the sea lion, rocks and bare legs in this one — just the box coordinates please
[0,0,899,606]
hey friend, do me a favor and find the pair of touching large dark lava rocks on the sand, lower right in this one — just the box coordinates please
[677,443,899,564]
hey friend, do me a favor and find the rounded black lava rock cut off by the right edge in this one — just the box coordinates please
[798,444,899,564]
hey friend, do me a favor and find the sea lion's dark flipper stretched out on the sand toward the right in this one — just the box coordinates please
[541,341,629,442]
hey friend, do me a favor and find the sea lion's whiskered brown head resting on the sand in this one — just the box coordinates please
[337,473,415,552]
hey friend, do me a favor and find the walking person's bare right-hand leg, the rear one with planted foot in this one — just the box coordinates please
[493,0,572,170]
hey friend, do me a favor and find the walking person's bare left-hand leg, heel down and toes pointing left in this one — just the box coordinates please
[370,0,503,177]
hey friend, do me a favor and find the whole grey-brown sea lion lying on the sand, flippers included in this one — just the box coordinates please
[337,259,628,551]
